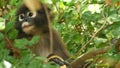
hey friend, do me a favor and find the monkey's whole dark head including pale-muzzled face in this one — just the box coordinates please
[15,4,51,35]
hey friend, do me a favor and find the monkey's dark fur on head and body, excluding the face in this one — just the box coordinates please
[15,4,69,59]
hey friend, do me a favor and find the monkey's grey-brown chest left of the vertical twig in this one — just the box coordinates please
[33,38,50,57]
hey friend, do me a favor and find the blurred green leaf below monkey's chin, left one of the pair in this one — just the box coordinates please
[14,38,28,49]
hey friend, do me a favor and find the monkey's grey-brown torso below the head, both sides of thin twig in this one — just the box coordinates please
[33,29,70,60]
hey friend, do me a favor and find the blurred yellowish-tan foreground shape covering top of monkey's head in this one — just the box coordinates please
[24,0,41,12]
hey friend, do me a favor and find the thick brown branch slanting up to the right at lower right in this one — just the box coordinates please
[71,46,112,68]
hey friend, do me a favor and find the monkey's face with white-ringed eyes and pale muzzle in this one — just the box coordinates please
[18,11,36,34]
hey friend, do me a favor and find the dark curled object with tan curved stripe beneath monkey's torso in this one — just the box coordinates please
[47,54,69,68]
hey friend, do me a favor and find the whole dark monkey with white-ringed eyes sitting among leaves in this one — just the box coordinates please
[15,0,70,60]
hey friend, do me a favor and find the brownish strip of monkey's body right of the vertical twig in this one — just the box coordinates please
[52,29,70,60]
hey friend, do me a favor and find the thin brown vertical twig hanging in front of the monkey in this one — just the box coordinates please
[44,5,53,53]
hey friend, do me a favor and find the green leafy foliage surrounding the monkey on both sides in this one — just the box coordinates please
[0,0,120,68]
